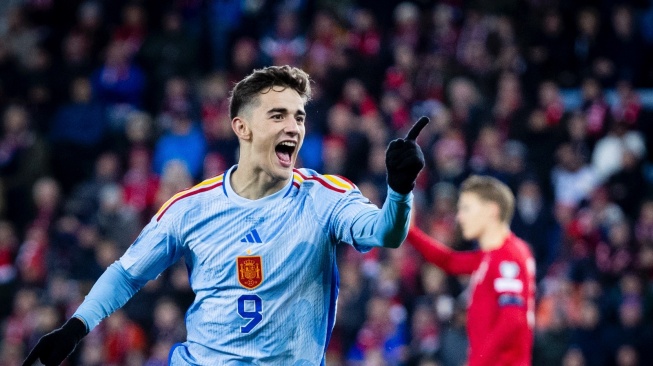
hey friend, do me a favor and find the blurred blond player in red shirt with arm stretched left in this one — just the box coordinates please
[407,176,535,366]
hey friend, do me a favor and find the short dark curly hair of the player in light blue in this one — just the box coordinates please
[229,65,311,119]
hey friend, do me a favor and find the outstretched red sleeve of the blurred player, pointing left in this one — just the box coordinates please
[408,226,483,274]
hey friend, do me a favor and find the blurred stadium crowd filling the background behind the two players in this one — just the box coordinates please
[0,0,653,366]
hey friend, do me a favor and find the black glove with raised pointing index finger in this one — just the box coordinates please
[385,117,429,194]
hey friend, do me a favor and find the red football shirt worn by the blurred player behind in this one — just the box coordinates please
[407,227,535,366]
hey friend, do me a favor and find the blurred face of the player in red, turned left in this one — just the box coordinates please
[456,192,491,240]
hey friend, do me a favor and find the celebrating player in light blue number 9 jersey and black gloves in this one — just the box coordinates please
[24,66,428,366]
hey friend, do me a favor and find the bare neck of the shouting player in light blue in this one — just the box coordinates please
[230,161,289,200]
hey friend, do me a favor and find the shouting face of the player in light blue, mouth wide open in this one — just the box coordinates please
[251,88,306,180]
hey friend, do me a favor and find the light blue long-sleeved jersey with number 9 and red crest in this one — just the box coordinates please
[70,167,412,365]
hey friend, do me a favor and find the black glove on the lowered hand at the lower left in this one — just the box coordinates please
[23,317,87,366]
